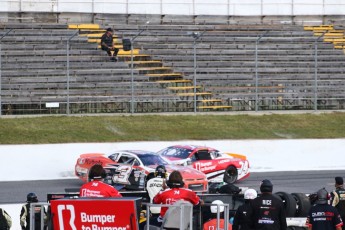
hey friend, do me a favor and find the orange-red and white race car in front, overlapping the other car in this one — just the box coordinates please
[75,150,208,192]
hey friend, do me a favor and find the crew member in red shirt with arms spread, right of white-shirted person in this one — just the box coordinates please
[150,171,203,227]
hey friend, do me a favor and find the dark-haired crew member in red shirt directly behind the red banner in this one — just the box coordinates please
[79,164,122,197]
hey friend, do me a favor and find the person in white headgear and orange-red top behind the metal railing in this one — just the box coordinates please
[203,200,232,230]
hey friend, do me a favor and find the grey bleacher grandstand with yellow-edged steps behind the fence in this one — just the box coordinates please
[0,9,345,115]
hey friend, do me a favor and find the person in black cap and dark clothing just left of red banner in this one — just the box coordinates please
[20,192,47,230]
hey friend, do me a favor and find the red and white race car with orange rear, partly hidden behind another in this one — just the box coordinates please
[157,145,250,184]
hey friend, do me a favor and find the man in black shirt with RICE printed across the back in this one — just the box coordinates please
[252,179,287,230]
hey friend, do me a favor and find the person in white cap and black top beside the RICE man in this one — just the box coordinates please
[232,189,258,230]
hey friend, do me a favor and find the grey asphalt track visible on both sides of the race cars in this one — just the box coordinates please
[0,170,345,204]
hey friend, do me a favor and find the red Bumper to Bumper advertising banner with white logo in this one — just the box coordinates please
[51,198,139,230]
